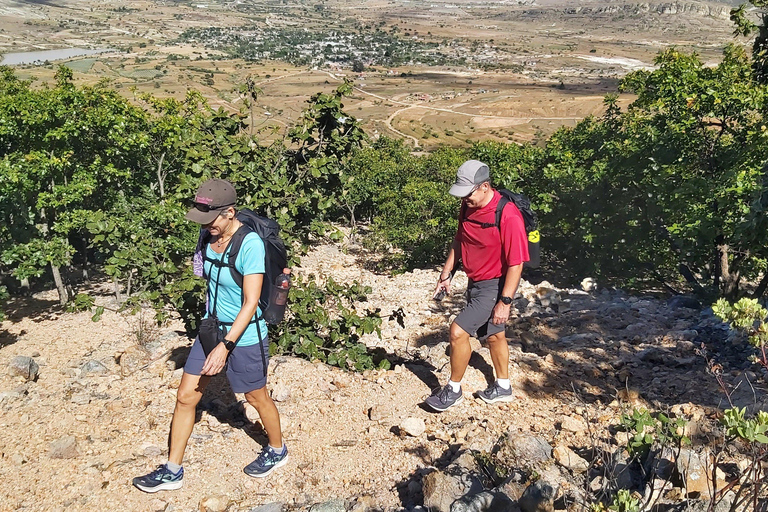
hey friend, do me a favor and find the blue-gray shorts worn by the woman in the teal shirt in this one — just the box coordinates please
[184,338,269,393]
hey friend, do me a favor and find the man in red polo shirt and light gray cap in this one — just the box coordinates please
[425,160,529,412]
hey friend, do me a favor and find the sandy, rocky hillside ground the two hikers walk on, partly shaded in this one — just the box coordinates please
[0,242,765,511]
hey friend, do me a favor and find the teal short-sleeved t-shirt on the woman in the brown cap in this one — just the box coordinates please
[205,232,267,346]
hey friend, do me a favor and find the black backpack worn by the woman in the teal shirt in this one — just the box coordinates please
[203,208,288,315]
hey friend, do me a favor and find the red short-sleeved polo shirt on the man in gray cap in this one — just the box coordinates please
[456,190,530,281]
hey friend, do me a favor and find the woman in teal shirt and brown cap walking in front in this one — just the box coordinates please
[133,179,288,492]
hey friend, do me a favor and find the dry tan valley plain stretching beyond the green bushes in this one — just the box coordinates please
[0,0,733,150]
